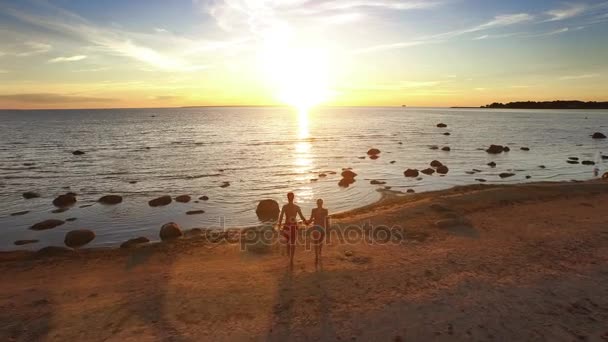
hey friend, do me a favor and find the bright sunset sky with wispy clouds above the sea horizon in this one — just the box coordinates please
[0,0,608,108]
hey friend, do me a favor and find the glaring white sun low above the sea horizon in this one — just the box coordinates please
[262,31,331,112]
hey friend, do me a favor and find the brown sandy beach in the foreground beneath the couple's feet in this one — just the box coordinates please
[0,181,608,341]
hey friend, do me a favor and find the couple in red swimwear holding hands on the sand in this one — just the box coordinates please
[278,192,329,265]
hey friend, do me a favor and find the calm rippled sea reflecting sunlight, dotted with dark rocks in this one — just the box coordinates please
[0,108,608,250]
